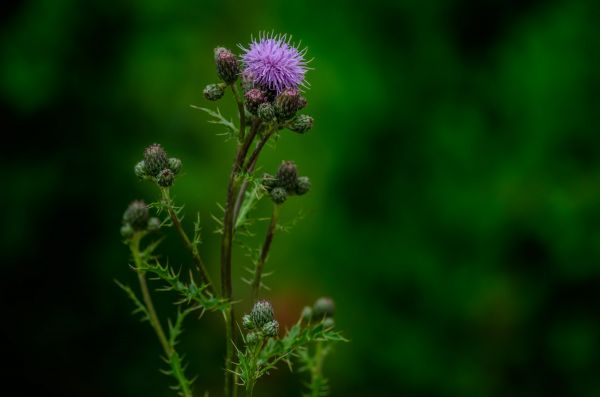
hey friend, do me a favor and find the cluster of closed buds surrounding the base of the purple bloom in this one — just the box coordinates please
[203,47,313,134]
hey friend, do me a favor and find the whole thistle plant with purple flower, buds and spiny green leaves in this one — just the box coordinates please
[117,34,345,397]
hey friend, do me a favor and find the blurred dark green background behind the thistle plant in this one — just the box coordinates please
[0,0,600,396]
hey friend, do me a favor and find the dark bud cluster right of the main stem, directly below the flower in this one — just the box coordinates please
[262,161,310,204]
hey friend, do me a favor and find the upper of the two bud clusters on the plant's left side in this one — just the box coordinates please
[135,143,181,187]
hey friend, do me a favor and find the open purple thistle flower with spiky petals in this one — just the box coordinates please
[240,35,308,93]
